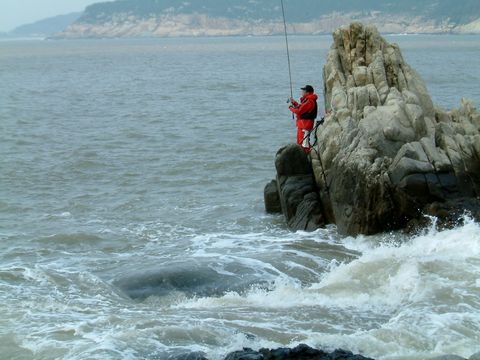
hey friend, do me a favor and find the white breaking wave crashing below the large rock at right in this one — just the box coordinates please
[173,219,480,359]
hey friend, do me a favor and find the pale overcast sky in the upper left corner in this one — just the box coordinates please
[0,0,109,32]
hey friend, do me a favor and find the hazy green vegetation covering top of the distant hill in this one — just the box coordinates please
[80,0,480,24]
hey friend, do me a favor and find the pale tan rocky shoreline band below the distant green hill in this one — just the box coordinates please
[52,12,480,39]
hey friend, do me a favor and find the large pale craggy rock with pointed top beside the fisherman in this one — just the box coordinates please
[266,23,480,235]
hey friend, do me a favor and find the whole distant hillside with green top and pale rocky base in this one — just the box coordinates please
[52,0,480,38]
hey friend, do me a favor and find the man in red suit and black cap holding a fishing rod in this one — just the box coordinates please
[290,85,318,153]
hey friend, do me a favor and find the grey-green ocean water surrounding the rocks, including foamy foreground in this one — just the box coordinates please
[0,36,480,360]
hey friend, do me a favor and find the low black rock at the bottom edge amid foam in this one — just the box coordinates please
[225,345,370,360]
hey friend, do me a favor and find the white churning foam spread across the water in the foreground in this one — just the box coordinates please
[4,219,480,360]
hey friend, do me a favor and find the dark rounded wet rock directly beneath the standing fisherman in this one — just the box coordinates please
[265,145,325,230]
